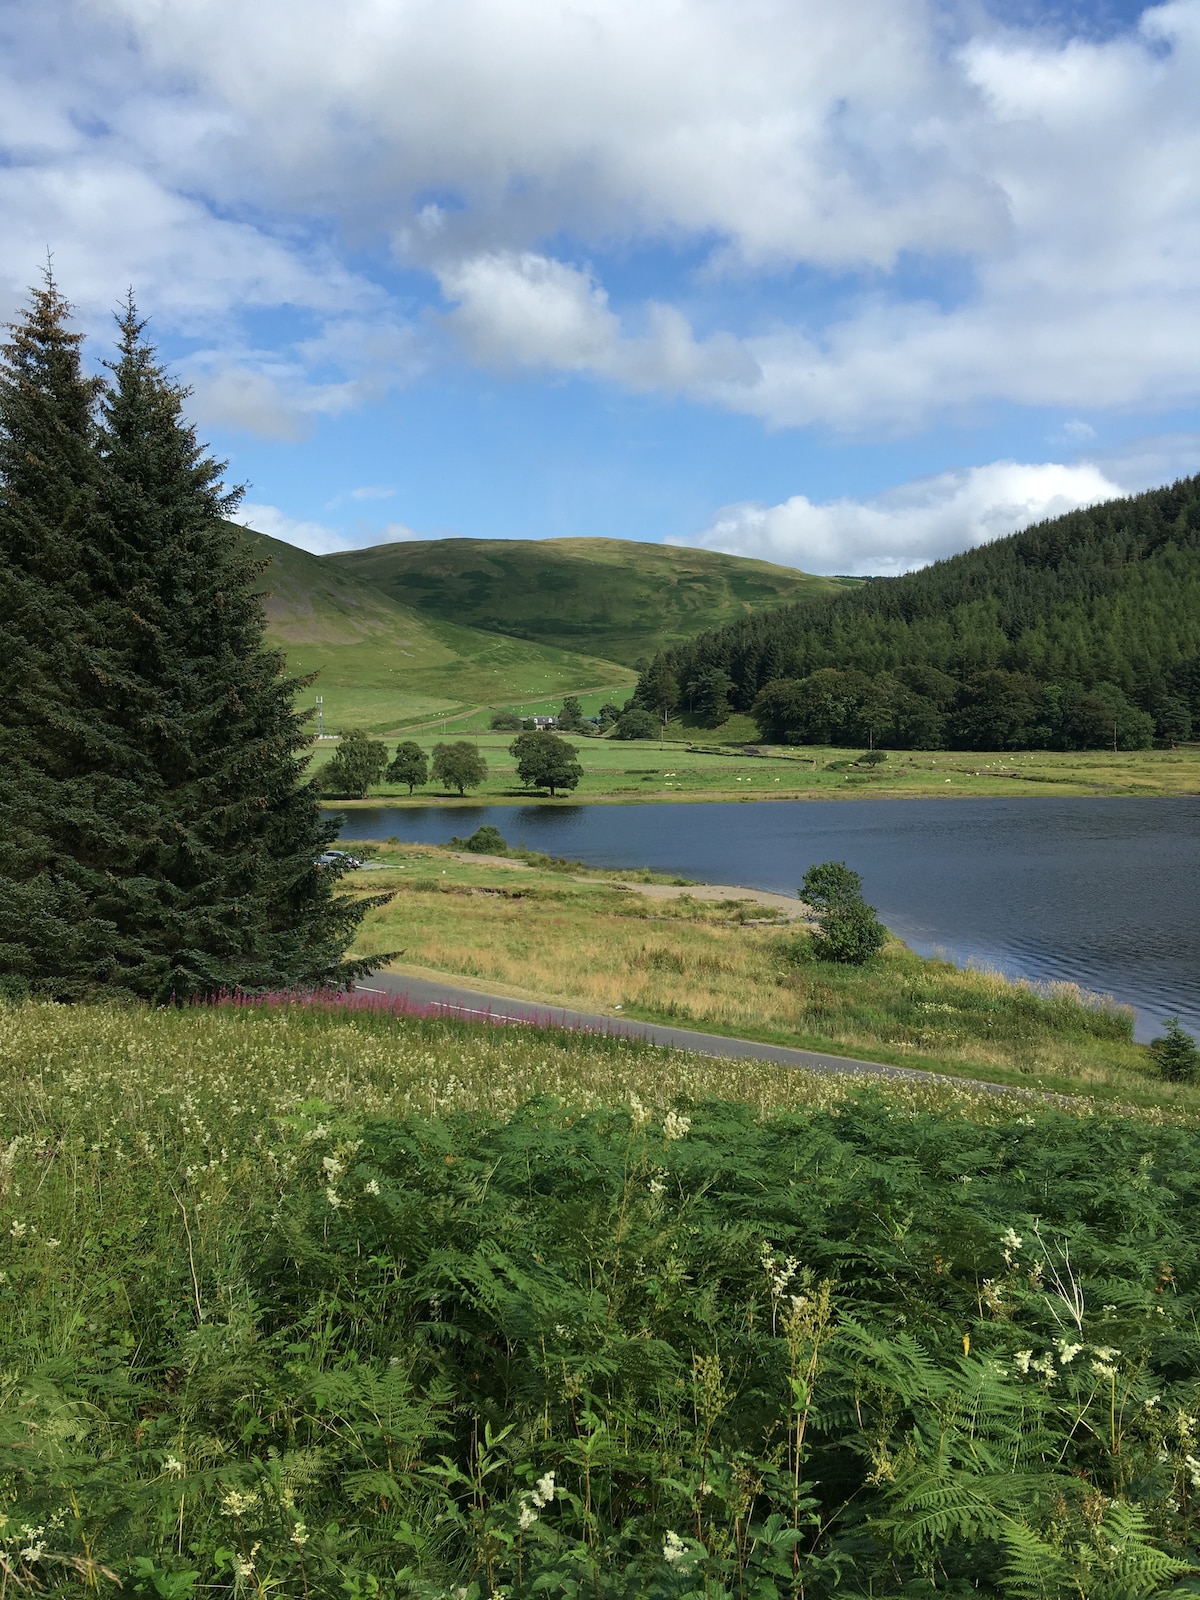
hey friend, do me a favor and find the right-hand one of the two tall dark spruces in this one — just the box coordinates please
[99,301,386,1000]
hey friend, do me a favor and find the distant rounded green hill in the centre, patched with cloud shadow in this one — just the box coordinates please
[322,539,858,666]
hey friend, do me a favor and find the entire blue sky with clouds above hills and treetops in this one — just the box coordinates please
[0,0,1200,573]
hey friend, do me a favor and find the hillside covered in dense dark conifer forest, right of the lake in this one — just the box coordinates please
[637,477,1200,749]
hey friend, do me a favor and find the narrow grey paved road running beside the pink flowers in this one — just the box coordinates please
[355,973,998,1088]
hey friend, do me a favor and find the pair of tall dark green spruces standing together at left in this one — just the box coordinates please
[0,272,385,1002]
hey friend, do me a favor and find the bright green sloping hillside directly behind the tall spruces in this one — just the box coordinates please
[248,533,634,731]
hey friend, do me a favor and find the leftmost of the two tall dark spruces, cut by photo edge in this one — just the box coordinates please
[0,269,141,998]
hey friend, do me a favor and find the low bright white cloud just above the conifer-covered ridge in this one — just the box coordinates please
[684,461,1125,576]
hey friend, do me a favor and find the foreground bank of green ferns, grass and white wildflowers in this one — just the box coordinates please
[0,1003,1200,1600]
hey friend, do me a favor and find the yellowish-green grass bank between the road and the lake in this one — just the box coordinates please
[342,845,1200,1109]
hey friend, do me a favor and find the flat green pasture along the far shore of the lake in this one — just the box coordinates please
[314,726,1200,805]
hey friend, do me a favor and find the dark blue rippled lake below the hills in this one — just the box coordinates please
[329,797,1200,1038]
